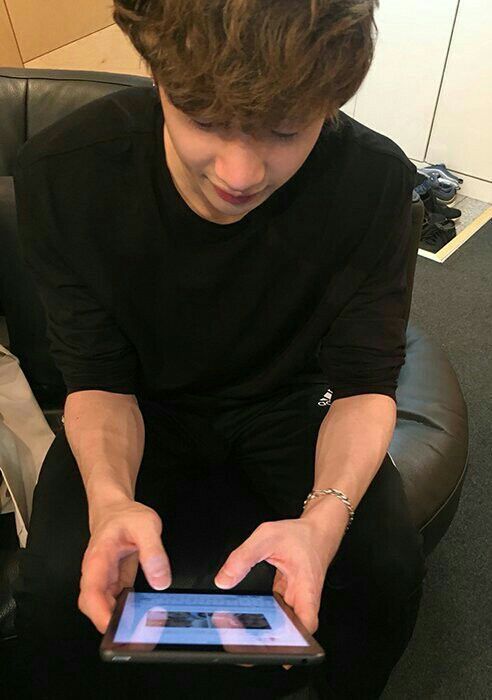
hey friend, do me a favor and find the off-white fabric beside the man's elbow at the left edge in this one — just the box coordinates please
[0,345,55,547]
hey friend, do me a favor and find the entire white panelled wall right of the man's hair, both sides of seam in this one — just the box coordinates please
[343,0,492,203]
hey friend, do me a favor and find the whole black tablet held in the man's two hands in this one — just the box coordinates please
[100,588,324,665]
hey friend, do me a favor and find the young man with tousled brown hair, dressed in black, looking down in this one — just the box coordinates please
[11,0,425,698]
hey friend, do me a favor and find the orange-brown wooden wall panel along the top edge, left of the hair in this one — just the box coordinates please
[4,0,113,63]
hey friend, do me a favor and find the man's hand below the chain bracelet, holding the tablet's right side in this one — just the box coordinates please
[215,499,347,668]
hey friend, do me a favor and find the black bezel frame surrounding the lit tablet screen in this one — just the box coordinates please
[99,588,325,665]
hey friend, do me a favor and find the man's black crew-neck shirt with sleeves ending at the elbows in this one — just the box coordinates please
[14,87,416,400]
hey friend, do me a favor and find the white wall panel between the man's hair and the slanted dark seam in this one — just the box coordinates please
[355,0,458,160]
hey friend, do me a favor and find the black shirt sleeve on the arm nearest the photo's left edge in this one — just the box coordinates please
[14,150,138,395]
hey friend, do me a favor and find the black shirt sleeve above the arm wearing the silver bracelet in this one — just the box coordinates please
[318,163,418,402]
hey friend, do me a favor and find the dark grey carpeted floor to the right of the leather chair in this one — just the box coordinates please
[382,222,492,700]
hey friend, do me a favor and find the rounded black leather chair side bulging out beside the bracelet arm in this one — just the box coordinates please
[389,323,468,535]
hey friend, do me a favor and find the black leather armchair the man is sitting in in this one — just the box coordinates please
[0,68,468,653]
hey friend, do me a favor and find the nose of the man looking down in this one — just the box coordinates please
[215,142,265,197]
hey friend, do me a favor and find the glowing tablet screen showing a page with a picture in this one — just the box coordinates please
[114,591,309,647]
